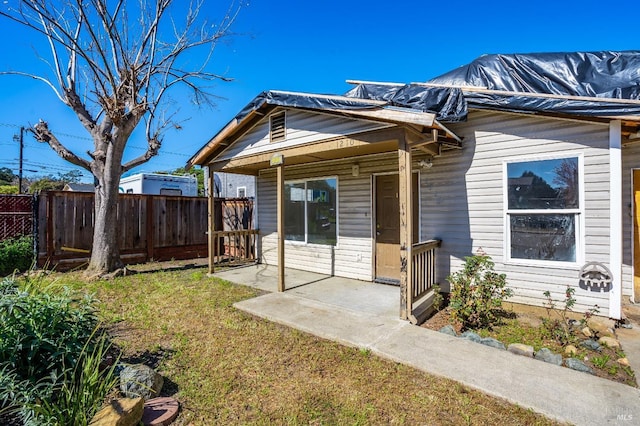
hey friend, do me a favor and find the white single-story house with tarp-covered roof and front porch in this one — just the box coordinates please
[189,52,640,321]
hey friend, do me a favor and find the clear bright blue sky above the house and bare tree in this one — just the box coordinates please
[0,0,640,181]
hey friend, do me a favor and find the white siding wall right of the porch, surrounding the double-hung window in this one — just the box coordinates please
[421,112,609,315]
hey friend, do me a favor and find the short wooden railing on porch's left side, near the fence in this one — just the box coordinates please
[212,229,258,265]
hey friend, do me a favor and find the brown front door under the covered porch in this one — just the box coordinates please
[374,173,418,284]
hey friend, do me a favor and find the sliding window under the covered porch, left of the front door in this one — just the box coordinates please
[284,178,337,246]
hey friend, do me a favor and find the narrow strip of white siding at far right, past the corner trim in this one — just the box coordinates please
[622,140,640,303]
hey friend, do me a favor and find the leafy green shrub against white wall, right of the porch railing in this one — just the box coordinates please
[447,254,513,328]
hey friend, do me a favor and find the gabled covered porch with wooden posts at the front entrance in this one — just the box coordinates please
[191,89,461,323]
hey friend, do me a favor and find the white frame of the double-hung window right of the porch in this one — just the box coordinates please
[502,152,585,268]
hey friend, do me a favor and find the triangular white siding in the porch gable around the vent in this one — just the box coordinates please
[216,110,390,161]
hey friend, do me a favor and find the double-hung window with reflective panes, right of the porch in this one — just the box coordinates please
[506,157,582,263]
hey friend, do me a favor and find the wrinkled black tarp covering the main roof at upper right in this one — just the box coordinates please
[346,51,640,122]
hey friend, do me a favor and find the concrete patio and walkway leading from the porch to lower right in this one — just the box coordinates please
[215,265,640,425]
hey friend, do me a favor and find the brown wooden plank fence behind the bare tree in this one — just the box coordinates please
[37,191,253,269]
